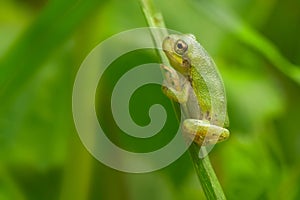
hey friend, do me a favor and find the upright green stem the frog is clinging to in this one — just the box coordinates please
[140,0,226,200]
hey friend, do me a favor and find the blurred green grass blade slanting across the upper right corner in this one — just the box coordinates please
[190,0,300,84]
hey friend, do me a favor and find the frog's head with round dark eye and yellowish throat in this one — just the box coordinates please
[162,34,196,75]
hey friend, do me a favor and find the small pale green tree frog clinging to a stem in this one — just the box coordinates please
[161,34,230,146]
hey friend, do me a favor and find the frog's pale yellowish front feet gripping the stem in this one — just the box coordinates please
[161,65,189,103]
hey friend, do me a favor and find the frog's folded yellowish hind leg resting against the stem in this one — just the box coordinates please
[183,119,229,146]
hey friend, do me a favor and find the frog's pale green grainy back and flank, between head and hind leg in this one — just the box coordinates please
[189,41,227,126]
